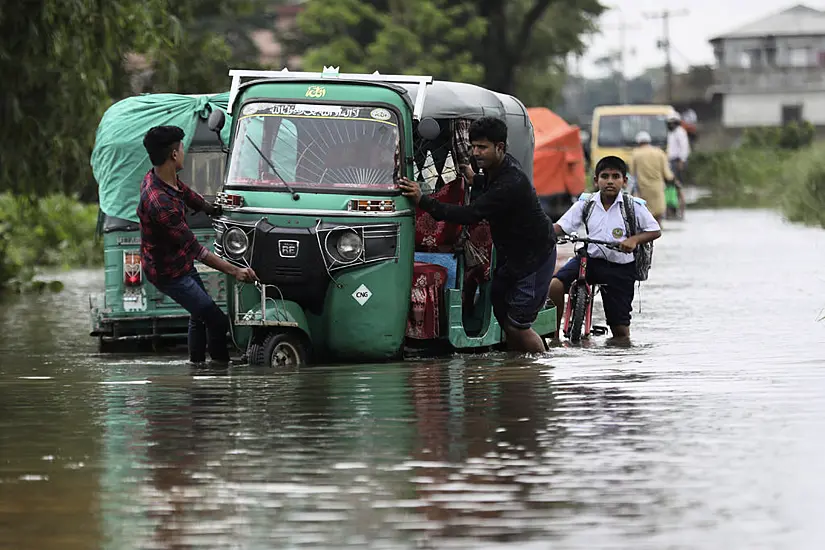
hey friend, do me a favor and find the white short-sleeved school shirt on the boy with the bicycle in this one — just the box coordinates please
[556,191,661,264]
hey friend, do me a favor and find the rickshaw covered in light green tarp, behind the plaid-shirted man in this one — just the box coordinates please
[89,92,229,351]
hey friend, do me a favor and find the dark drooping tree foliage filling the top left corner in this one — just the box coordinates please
[0,0,163,194]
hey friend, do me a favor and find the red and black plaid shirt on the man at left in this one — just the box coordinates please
[137,170,208,284]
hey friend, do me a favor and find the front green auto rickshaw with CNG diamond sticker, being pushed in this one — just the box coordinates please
[204,68,556,366]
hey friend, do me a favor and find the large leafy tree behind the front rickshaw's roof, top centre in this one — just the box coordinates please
[293,0,604,104]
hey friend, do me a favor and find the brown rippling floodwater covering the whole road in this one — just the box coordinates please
[0,210,825,550]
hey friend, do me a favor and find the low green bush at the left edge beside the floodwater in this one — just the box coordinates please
[0,193,103,294]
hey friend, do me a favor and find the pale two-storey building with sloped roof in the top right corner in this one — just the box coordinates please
[710,5,825,128]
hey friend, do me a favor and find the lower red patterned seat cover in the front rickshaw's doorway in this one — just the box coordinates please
[407,262,447,340]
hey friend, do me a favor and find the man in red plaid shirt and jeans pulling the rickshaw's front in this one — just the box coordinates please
[137,126,258,365]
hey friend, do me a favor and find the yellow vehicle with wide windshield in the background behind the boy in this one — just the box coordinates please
[590,105,674,166]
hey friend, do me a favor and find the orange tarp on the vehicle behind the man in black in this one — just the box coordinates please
[527,107,585,197]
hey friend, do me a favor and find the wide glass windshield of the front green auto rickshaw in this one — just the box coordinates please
[227,102,400,191]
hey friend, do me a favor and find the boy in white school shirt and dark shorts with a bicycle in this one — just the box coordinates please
[550,156,662,342]
